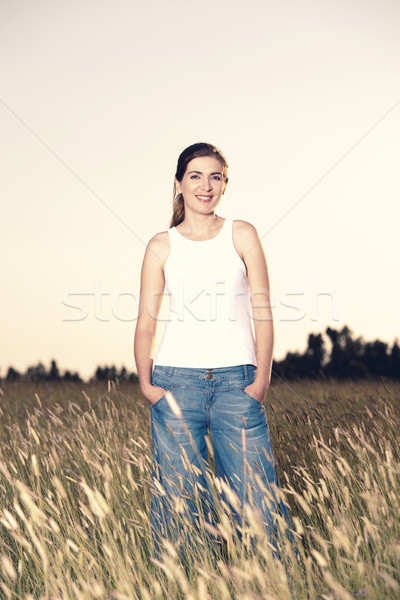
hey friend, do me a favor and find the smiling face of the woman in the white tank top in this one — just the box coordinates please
[175,156,226,214]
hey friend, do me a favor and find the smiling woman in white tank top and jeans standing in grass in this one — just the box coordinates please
[135,143,294,560]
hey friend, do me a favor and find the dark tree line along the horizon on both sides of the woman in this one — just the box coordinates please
[4,325,400,383]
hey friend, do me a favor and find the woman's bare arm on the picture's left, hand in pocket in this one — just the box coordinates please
[134,232,169,404]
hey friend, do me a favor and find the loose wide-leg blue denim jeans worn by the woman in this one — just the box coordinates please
[151,365,290,557]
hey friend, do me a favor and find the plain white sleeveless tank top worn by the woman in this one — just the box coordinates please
[154,219,257,369]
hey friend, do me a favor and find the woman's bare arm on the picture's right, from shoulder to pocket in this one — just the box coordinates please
[233,221,274,402]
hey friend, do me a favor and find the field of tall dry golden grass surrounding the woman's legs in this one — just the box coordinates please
[0,381,400,600]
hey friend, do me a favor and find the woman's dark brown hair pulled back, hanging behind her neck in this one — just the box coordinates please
[170,142,228,227]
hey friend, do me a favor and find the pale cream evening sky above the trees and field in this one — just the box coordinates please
[0,0,400,378]
